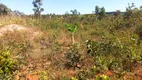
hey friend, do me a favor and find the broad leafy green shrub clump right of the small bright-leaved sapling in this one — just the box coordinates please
[87,34,140,73]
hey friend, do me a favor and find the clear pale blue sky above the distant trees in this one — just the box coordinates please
[0,0,142,14]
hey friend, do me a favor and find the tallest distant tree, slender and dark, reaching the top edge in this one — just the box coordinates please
[33,0,44,17]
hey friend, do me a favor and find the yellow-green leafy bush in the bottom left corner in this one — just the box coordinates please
[0,49,18,79]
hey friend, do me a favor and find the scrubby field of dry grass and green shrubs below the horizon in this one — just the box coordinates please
[0,9,142,80]
